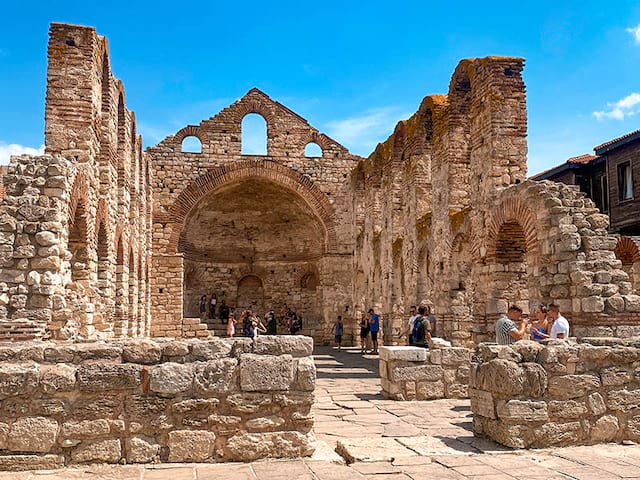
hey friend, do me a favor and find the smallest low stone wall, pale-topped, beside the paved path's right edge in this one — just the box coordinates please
[380,347,471,400]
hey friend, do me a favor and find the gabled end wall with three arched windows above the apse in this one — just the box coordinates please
[149,89,358,342]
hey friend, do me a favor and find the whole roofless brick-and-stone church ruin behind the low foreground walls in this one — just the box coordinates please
[0,24,640,348]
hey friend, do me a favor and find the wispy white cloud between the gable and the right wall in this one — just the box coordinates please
[326,107,410,156]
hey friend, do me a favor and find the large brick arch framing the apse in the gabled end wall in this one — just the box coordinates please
[167,160,337,253]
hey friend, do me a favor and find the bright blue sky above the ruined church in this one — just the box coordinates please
[0,0,640,174]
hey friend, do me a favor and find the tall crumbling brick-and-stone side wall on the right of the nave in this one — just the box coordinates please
[350,57,640,347]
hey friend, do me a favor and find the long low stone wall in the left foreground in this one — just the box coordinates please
[0,336,316,470]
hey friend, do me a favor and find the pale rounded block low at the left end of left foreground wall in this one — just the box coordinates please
[7,417,58,453]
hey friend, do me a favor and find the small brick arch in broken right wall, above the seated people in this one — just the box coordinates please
[487,198,539,259]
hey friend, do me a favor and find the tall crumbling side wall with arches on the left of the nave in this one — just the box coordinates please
[0,23,151,339]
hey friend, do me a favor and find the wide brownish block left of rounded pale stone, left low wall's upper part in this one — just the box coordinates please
[78,363,142,392]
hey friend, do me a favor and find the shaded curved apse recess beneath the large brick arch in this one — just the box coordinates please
[178,177,327,321]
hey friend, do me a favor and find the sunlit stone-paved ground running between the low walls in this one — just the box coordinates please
[7,348,640,480]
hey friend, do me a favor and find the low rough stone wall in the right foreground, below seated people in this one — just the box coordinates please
[469,338,640,448]
